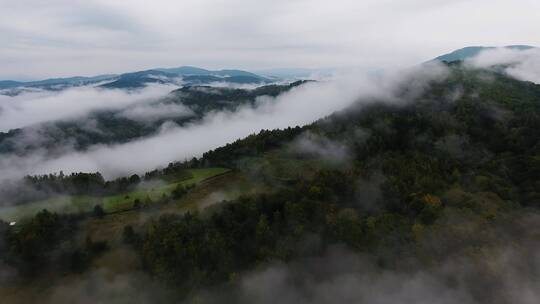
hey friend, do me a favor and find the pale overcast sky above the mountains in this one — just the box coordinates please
[0,0,540,79]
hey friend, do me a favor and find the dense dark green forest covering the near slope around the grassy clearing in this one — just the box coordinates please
[0,62,540,303]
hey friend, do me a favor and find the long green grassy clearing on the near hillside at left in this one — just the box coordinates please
[0,168,229,221]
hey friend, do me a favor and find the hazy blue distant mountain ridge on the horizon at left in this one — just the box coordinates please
[0,66,270,89]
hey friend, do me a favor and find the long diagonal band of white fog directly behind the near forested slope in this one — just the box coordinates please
[0,65,446,178]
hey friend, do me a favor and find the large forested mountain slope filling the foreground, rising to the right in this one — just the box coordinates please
[0,63,540,304]
